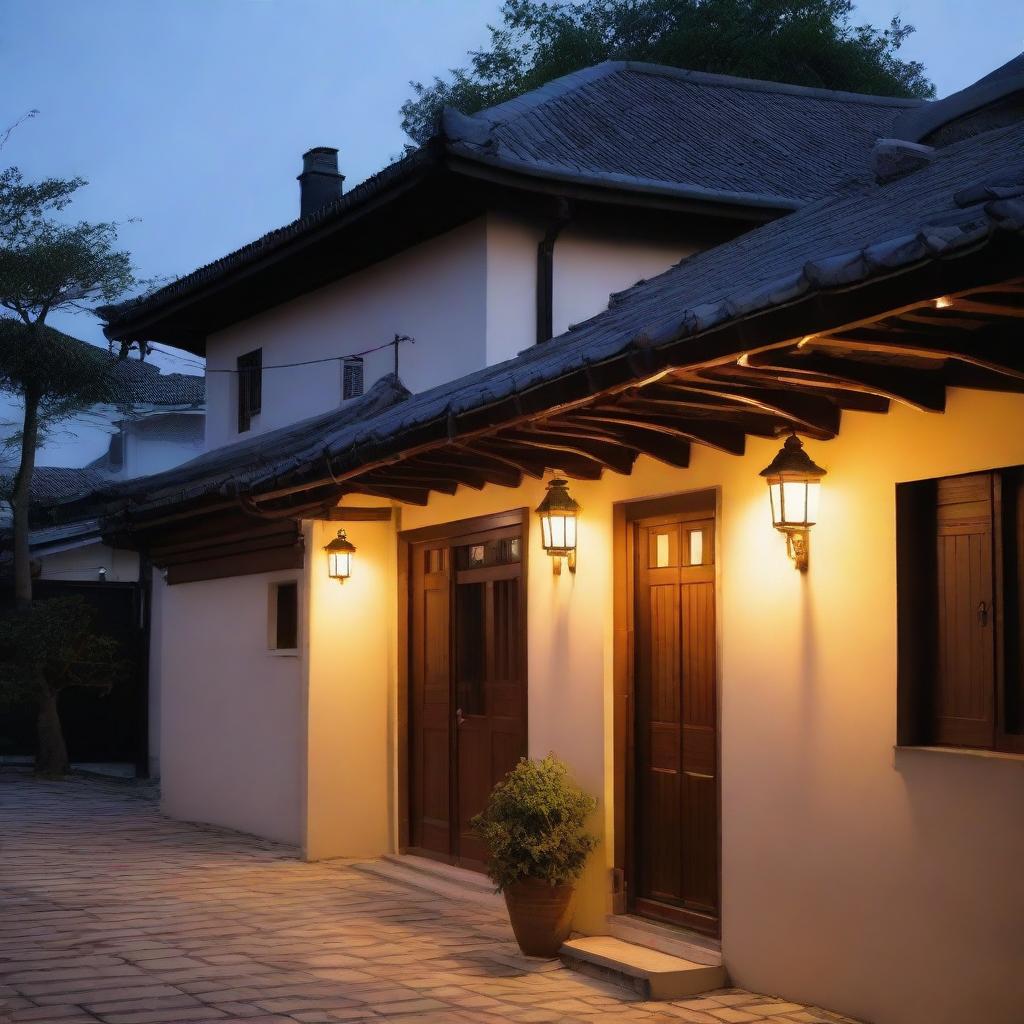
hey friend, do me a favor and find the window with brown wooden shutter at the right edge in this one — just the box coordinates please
[897,467,1024,753]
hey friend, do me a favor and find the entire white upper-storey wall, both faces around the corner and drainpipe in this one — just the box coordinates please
[206,213,694,449]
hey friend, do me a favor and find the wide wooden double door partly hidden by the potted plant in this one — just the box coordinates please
[409,517,526,869]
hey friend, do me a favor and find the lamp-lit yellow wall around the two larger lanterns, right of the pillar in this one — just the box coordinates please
[395,391,1024,1024]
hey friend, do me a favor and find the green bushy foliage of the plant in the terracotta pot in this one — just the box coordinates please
[471,754,597,892]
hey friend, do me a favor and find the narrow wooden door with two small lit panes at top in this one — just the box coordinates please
[630,513,719,932]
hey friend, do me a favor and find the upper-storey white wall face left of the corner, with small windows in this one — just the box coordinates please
[206,218,486,449]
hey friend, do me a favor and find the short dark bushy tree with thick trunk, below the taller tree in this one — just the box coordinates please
[0,597,128,777]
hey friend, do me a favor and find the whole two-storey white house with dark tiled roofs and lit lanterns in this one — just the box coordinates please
[75,59,1024,1024]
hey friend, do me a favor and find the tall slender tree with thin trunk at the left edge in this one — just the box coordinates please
[0,167,136,608]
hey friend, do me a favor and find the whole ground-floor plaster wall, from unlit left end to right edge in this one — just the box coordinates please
[155,391,1024,1024]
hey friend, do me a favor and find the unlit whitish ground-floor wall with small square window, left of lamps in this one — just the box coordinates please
[151,570,305,846]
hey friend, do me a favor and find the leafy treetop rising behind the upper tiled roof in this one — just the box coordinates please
[401,0,935,143]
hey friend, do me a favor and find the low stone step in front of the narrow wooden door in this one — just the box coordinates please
[559,935,726,999]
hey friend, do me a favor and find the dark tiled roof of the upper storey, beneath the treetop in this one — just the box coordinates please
[99,61,922,325]
